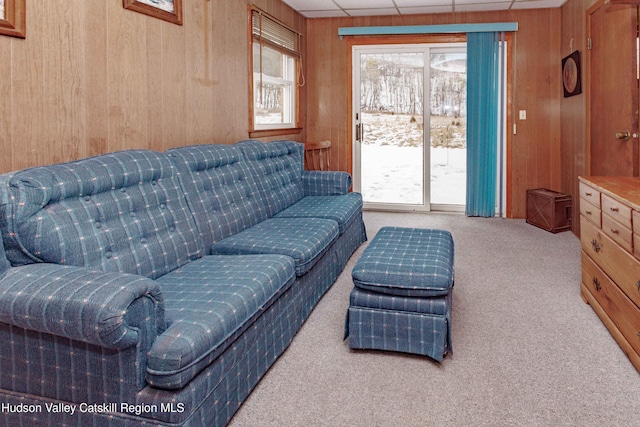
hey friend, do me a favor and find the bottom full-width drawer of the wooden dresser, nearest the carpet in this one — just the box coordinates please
[582,252,640,353]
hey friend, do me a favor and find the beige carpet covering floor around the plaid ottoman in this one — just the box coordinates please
[230,212,640,427]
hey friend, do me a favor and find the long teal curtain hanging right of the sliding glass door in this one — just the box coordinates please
[466,32,500,217]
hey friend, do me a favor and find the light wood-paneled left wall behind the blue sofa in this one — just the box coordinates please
[0,0,306,172]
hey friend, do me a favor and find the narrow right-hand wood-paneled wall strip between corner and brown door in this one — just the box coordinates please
[560,0,597,234]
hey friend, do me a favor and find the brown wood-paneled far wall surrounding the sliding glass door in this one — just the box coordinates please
[306,9,562,218]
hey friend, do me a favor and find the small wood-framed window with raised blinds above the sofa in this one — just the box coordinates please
[250,7,301,131]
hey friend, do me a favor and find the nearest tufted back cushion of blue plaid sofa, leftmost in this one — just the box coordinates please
[4,150,203,279]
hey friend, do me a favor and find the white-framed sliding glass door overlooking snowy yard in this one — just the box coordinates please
[353,44,466,211]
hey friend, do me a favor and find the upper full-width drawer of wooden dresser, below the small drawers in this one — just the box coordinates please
[580,215,640,306]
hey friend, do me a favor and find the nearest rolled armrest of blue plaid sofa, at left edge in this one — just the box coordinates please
[0,263,164,349]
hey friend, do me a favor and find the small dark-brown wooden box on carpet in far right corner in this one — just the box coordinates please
[527,188,571,233]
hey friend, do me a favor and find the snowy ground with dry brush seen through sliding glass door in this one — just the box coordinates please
[361,113,467,205]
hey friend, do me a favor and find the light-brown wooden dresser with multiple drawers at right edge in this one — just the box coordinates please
[579,177,640,371]
